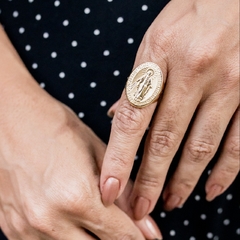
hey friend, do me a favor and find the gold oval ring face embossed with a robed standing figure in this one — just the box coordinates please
[126,62,164,108]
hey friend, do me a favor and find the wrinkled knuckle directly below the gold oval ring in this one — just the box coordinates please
[114,101,144,134]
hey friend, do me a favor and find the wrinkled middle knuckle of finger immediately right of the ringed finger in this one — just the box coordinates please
[149,130,178,157]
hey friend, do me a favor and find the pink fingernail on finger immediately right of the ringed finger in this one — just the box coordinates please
[133,197,150,220]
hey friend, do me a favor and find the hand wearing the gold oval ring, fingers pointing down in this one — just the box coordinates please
[100,0,239,219]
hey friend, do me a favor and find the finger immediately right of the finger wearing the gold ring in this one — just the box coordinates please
[131,74,201,219]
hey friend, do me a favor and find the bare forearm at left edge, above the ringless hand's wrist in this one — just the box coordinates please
[0,26,58,124]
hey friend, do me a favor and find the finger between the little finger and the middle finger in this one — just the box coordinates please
[163,93,238,210]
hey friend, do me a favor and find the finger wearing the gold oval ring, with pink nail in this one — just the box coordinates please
[100,58,166,206]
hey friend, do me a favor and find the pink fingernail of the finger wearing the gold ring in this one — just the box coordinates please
[102,177,120,207]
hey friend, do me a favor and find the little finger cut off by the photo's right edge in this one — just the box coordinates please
[206,107,240,201]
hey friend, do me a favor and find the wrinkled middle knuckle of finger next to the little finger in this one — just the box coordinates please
[187,140,215,163]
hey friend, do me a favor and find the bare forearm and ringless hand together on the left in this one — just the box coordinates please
[0,27,161,240]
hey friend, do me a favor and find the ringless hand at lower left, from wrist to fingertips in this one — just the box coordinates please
[0,100,161,240]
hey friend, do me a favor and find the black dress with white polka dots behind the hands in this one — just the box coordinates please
[0,0,240,240]
